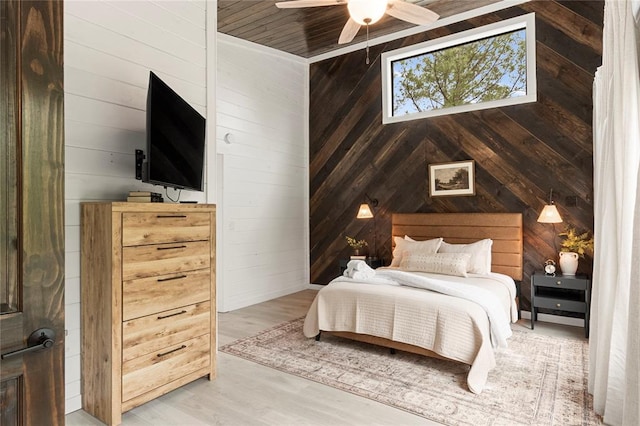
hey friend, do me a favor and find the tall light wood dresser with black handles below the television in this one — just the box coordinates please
[80,202,216,424]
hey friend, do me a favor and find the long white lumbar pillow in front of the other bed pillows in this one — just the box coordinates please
[400,251,471,277]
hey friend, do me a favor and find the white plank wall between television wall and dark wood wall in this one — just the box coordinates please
[216,34,309,312]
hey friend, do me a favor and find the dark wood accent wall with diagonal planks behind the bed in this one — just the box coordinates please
[309,1,604,307]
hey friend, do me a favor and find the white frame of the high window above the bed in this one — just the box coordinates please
[381,13,537,124]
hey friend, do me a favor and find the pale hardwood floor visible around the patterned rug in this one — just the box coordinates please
[66,290,584,426]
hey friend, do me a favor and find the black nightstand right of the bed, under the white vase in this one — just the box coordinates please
[531,272,591,338]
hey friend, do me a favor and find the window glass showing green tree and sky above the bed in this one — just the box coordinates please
[392,29,527,116]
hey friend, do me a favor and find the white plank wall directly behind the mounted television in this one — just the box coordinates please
[64,0,208,413]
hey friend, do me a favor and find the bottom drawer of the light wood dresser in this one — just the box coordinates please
[122,334,211,402]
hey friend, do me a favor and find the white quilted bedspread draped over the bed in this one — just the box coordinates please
[304,268,517,393]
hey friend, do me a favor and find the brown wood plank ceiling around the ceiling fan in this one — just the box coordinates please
[218,0,502,58]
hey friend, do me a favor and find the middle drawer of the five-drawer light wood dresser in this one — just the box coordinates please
[122,269,211,321]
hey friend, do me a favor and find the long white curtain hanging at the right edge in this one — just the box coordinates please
[589,0,640,426]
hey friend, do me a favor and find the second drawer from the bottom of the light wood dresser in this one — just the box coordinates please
[122,302,213,361]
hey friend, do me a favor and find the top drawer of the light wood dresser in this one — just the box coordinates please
[122,212,211,246]
